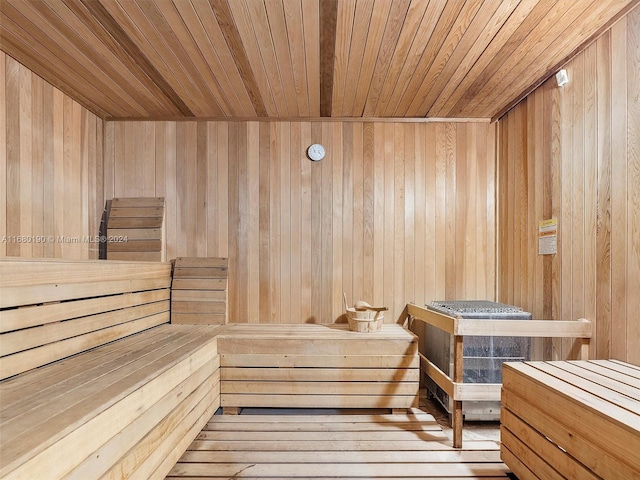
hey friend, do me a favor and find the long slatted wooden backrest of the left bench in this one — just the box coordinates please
[0,258,171,380]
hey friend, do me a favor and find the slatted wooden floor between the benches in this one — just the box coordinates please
[167,409,508,480]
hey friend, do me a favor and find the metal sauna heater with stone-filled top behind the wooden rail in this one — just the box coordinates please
[424,300,531,421]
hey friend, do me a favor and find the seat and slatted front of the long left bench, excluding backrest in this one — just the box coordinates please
[0,324,225,479]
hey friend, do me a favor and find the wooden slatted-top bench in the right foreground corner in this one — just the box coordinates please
[500,360,640,480]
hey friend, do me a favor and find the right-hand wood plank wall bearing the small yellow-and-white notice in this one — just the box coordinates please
[498,9,640,364]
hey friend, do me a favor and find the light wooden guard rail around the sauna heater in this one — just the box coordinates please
[405,303,591,448]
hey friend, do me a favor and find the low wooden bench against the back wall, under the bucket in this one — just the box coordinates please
[218,324,419,408]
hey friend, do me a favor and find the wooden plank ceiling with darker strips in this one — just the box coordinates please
[0,0,640,118]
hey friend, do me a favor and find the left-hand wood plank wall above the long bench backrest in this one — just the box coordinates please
[0,51,104,259]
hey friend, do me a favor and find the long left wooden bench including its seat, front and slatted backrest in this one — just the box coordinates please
[0,259,225,479]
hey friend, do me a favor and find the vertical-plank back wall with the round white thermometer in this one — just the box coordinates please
[104,121,495,323]
